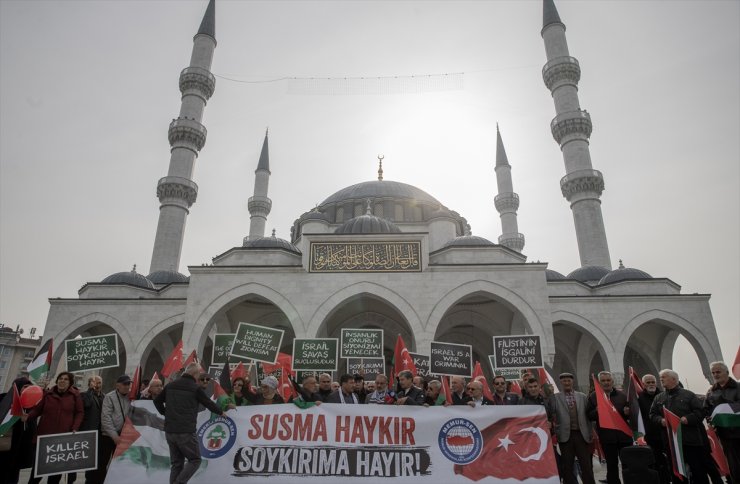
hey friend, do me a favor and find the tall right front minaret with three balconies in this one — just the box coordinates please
[542,0,612,269]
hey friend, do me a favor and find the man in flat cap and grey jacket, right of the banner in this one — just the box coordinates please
[547,372,594,484]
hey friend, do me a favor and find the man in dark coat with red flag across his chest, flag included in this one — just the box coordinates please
[586,371,633,484]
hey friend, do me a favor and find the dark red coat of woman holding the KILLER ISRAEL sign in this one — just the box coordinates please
[28,385,84,443]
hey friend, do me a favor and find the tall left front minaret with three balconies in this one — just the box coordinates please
[149,0,216,273]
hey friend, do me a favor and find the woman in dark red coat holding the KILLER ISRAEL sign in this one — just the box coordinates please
[21,371,84,484]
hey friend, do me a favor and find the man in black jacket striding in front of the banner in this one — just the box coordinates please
[154,363,224,484]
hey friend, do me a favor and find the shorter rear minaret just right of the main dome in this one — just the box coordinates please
[493,123,524,252]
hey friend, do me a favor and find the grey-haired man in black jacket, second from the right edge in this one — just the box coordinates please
[650,370,709,484]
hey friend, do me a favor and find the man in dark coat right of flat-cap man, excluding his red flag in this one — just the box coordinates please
[586,371,633,484]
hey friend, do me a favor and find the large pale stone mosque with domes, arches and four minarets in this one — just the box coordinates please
[36,0,722,392]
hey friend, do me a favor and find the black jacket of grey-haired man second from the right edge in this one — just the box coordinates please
[650,387,709,445]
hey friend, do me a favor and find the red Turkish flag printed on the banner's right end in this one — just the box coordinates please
[455,413,558,481]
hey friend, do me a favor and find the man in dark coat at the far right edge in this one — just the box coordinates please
[704,361,740,483]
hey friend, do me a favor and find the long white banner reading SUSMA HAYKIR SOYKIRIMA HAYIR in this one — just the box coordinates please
[108,401,560,484]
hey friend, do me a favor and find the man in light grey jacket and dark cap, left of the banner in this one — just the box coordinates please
[98,375,131,476]
